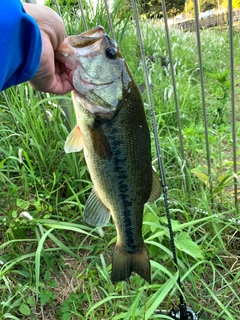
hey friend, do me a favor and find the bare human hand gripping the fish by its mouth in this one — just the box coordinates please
[23,3,74,94]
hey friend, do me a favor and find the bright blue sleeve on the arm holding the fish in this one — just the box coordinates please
[0,0,42,91]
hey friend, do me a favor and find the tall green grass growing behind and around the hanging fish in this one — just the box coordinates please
[0,2,240,320]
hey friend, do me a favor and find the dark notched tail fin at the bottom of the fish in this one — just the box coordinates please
[111,245,151,283]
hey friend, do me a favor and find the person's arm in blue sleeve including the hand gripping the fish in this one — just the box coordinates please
[0,0,73,94]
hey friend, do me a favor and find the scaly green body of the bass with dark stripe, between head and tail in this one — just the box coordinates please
[80,92,152,282]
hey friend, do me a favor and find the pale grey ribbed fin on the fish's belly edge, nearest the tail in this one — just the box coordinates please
[83,189,111,226]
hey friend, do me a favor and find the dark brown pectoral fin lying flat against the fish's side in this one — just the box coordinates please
[90,124,112,160]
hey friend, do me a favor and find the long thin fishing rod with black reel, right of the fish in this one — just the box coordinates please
[132,0,198,320]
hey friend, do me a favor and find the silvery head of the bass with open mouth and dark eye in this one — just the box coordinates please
[55,26,124,116]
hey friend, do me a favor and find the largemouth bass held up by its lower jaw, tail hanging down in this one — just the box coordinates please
[56,26,161,283]
